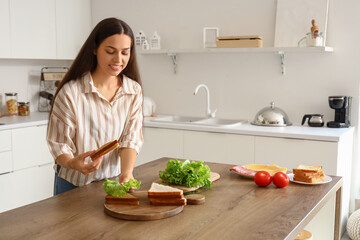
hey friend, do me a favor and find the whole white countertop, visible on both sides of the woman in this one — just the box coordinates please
[0,112,354,142]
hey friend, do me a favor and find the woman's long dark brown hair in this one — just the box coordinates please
[50,18,142,115]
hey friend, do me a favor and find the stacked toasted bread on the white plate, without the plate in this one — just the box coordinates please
[293,164,325,183]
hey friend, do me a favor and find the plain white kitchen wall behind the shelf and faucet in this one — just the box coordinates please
[92,0,360,210]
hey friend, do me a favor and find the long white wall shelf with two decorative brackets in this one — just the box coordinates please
[139,46,334,75]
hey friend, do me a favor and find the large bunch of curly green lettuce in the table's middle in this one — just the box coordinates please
[159,159,212,188]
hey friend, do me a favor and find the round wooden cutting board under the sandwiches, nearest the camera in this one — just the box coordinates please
[104,191,184,220]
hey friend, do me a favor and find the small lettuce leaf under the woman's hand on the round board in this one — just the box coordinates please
[103,179,141,197]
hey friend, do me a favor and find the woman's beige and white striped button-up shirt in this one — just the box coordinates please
[47,73,143,186]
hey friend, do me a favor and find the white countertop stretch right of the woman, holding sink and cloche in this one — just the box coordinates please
[144,116,354,142]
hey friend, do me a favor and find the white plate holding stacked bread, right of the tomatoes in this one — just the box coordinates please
[288,164,332,185]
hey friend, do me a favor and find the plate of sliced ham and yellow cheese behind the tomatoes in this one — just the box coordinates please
[230,164,287,179]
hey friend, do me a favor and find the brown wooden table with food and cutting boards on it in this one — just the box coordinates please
[0,158,342,240]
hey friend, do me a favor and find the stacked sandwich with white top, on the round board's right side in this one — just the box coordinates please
[148,183,186,206]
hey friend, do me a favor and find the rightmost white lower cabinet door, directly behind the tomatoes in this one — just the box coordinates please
[255,137,338,175]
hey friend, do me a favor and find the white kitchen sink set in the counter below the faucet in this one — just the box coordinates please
[151,116,247,127]
